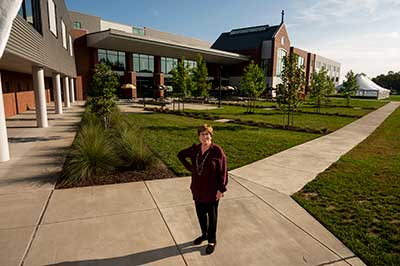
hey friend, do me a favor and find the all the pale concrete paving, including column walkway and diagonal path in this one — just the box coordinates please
[0,103,398,266]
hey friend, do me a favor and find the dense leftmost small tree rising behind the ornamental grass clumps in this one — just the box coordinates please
[87,63,119,128]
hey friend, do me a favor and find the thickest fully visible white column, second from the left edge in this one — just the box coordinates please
[32,66,49,127]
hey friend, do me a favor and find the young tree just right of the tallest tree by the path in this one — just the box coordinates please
[310,69,335,112]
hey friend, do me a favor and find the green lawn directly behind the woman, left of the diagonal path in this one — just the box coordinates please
[129,113,320,176]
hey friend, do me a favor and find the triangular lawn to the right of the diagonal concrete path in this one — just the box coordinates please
[293,105,400,266]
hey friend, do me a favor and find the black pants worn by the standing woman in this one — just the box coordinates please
[195,200,219,243]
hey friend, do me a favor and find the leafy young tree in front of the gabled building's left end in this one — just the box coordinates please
[240,61,267,113]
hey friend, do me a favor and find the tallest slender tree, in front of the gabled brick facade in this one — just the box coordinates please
[276,53,305,126]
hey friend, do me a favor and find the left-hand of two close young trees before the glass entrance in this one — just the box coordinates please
[171,57,192,97]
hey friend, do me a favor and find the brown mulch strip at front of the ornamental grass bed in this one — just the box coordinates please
[56,160,177,189]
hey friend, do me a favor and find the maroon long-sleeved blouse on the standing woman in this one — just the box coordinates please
[178,143,228,203]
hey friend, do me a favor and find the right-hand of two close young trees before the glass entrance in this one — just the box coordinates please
[192,54,211,97]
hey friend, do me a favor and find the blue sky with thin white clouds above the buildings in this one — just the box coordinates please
[66,0,400,79]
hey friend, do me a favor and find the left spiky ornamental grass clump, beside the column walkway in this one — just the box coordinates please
[61,119,118,185]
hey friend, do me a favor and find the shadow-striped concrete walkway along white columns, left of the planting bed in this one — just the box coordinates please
[0,102,83,266]
